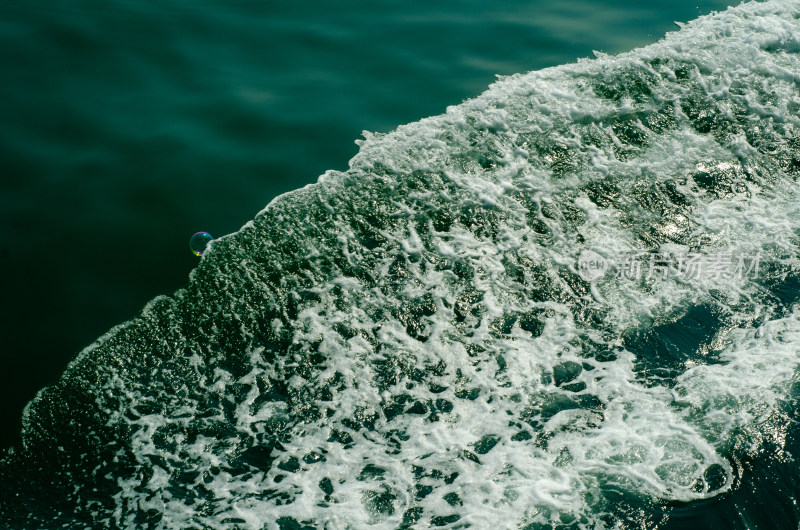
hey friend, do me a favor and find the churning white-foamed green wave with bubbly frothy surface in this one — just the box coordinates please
[0,0,800,528]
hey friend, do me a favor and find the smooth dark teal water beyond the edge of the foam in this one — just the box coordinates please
[0,0,728,446]
